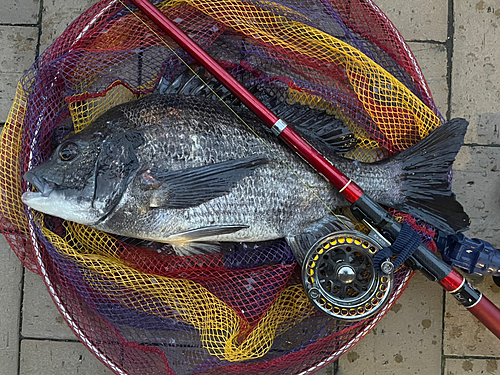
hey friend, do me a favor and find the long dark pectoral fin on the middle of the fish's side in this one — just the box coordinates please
[147,155,269,208]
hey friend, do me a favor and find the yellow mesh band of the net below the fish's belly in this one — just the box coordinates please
[38,220,314,361]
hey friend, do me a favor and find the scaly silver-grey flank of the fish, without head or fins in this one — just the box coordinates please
[92,96,398,241]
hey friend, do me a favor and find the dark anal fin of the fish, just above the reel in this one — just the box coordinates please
[285,215,354,264]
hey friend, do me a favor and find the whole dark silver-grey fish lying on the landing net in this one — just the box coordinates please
[22,93,469,255]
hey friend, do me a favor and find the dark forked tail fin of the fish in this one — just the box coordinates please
[393,118,470,233]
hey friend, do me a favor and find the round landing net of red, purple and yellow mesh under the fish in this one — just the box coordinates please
[0,0,443,374]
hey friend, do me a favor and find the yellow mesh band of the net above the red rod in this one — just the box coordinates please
[159,0,441,150]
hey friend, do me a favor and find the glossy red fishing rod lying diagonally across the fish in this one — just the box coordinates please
[132,0,500,339]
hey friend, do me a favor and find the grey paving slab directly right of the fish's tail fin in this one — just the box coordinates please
[453,146,500,249]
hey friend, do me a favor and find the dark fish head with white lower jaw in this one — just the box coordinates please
[21,132,138,225]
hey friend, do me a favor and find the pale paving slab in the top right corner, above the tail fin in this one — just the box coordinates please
[451,0,500,144]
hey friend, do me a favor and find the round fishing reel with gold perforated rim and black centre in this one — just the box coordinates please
[302,231,394,321]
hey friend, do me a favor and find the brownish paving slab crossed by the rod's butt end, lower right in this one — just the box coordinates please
[443,276,500,357]
